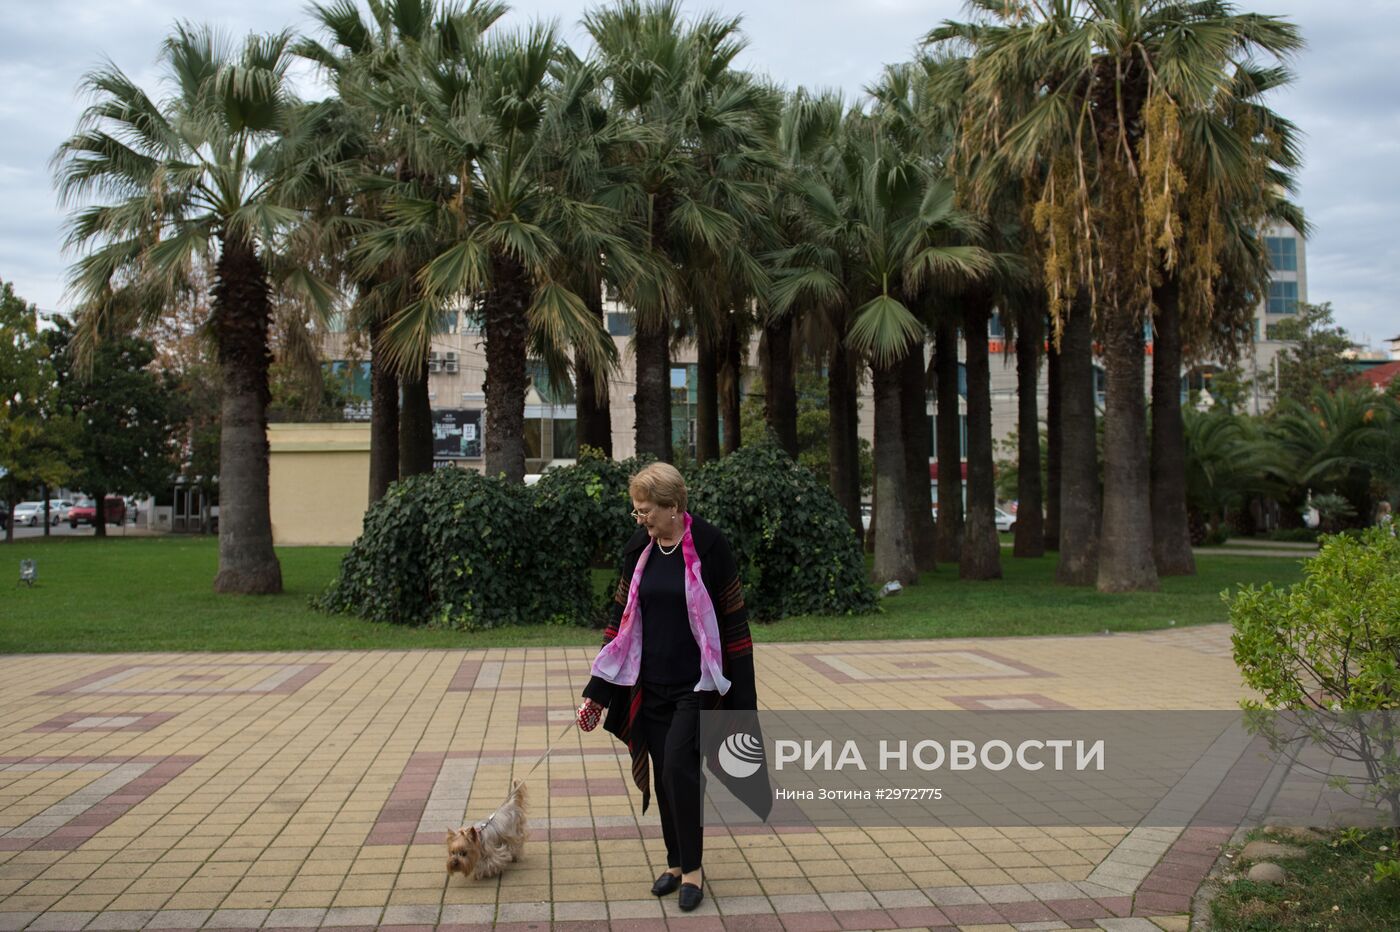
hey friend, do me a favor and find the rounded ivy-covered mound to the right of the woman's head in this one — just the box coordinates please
[686,442,875,621]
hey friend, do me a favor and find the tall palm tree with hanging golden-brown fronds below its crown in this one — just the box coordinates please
[932,0,1299,591]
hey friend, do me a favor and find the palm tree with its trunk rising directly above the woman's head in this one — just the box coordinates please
[584,0,778,460]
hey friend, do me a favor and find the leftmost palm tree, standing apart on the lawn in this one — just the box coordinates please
[55,24,334,593]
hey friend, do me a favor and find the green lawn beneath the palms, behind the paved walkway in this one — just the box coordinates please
[0,536,1301,654]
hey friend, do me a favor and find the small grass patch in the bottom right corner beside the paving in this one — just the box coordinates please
[1211,830,1400,932]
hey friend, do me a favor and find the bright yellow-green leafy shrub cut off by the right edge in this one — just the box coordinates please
[1226,528,1400,820]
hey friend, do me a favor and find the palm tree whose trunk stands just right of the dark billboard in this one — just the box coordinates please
[360,25,624,481]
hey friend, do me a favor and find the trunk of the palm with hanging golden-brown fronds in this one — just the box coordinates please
[1098,306,1158,592]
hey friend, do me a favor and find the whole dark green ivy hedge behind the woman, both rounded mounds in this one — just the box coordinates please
[312,444,876,630]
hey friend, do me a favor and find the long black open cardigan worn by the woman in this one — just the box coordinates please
[584,515,759,812]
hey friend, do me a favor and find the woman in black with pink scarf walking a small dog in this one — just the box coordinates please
[578,463,757,912]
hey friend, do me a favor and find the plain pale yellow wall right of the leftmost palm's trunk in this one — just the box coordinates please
[267,423,370,547]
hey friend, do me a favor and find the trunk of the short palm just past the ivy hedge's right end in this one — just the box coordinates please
[871,362,918,586]
